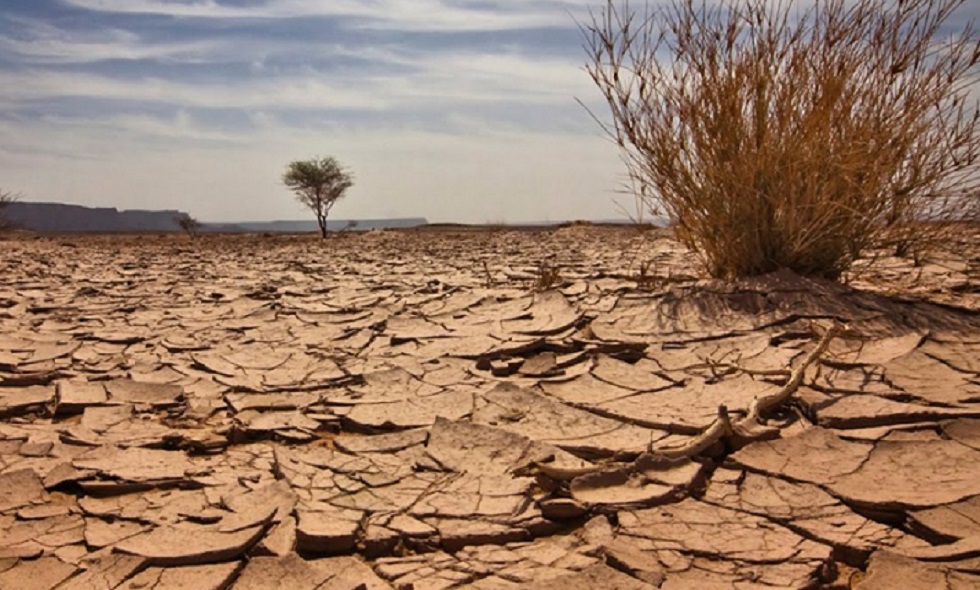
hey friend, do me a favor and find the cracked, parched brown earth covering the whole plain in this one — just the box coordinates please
[0,226,980,590]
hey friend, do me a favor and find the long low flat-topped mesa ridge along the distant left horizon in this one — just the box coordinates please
[4,201,428,233]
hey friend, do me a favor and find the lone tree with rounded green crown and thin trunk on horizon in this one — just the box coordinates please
[282,157,354,238]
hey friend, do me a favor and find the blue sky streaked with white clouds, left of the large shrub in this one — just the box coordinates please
[0,0,632,223]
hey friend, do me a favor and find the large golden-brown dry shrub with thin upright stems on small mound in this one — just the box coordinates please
[583,0,980,278]
